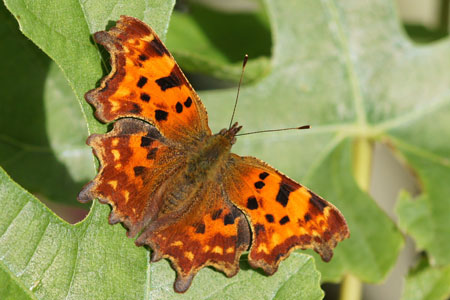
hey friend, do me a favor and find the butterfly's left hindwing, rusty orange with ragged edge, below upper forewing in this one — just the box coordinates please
[78,118,185,237]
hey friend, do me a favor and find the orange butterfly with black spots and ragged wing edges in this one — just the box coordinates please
[78,16,349,293]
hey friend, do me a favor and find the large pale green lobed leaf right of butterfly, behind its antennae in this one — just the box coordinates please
[202,0,450,292]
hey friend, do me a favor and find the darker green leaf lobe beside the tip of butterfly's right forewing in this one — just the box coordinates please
[305,139,403,282]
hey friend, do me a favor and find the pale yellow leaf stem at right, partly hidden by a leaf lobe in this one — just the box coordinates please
[339,138,373,300]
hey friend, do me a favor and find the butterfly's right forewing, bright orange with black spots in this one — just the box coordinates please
[224,154,349,274]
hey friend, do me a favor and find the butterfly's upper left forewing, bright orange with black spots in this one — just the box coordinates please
[85,16,211,141]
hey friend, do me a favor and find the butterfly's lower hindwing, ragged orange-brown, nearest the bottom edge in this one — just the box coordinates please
[136,182,250,292]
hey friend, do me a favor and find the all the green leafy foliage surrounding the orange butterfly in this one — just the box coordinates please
[0,0,450,299]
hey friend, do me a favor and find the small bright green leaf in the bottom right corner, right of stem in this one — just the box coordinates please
[402,266,450,300]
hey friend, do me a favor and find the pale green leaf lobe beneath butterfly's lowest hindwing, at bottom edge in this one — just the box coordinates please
[149,253,323,300]
